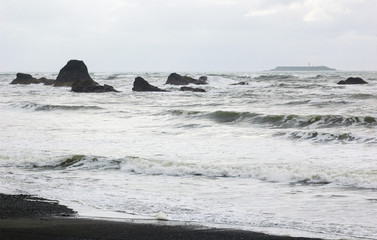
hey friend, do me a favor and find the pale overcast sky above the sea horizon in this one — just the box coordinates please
[0,0,377,72]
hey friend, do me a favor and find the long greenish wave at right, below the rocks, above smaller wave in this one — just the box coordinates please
[170,110,377,128]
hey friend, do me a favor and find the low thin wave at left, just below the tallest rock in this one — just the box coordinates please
[15,102,102,111]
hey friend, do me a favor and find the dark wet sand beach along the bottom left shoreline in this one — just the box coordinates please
[0,193,324,240]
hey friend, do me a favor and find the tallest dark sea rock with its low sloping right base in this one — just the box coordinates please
[54,60,117,93]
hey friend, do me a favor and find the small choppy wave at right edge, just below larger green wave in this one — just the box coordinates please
[276,131,377,143]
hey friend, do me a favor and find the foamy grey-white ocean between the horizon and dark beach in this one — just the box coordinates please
[0,71,377,239]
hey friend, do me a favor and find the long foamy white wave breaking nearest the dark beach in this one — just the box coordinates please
[32,155,377,189]
